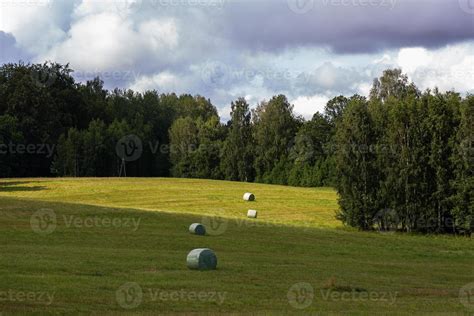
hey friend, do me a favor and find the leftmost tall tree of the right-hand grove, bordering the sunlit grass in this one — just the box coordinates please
[336,96,379,230]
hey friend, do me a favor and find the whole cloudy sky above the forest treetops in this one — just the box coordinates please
[0,0,474,119]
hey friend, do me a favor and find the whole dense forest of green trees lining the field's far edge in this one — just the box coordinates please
[0,63,474,233]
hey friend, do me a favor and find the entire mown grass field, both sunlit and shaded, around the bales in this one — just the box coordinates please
[0,179,474,315]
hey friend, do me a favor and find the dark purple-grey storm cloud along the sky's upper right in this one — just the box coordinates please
[221,0,474,53]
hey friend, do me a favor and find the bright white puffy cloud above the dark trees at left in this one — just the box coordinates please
[40,12,178,71]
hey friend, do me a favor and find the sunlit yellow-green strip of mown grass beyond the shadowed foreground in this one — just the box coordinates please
[0,178,341,228]
